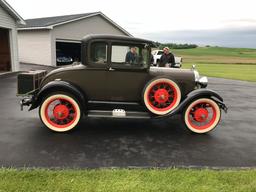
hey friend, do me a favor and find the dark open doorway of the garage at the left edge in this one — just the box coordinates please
[0,28,11,71]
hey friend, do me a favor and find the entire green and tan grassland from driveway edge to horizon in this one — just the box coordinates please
[169,47,256,82]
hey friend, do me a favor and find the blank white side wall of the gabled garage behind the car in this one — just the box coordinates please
[18,30,52,65]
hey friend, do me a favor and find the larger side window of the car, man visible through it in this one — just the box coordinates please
[111,45,149,67]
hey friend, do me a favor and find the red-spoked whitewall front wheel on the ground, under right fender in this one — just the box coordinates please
[184,98,221,133]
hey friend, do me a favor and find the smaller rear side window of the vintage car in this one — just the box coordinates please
[90,42,108,64]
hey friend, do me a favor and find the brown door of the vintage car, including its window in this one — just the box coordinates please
[107,44,149,102]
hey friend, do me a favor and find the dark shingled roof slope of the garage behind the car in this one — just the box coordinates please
[18,12,100,28]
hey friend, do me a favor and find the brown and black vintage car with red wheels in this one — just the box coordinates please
[18,35,227,133]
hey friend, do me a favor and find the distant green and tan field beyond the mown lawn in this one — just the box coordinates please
[172,47,256,64]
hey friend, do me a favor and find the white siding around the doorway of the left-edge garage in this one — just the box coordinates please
[0,6,19,71]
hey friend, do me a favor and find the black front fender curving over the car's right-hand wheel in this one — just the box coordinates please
[157,88,227,117]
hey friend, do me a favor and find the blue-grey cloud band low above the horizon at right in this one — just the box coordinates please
[138,27,256,48]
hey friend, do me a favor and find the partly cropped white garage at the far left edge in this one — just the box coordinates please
[0,0,25,73]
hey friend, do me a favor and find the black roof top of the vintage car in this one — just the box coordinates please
[82,34,156,47]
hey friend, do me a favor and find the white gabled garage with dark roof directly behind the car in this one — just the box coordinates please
[18,12,132,66]
